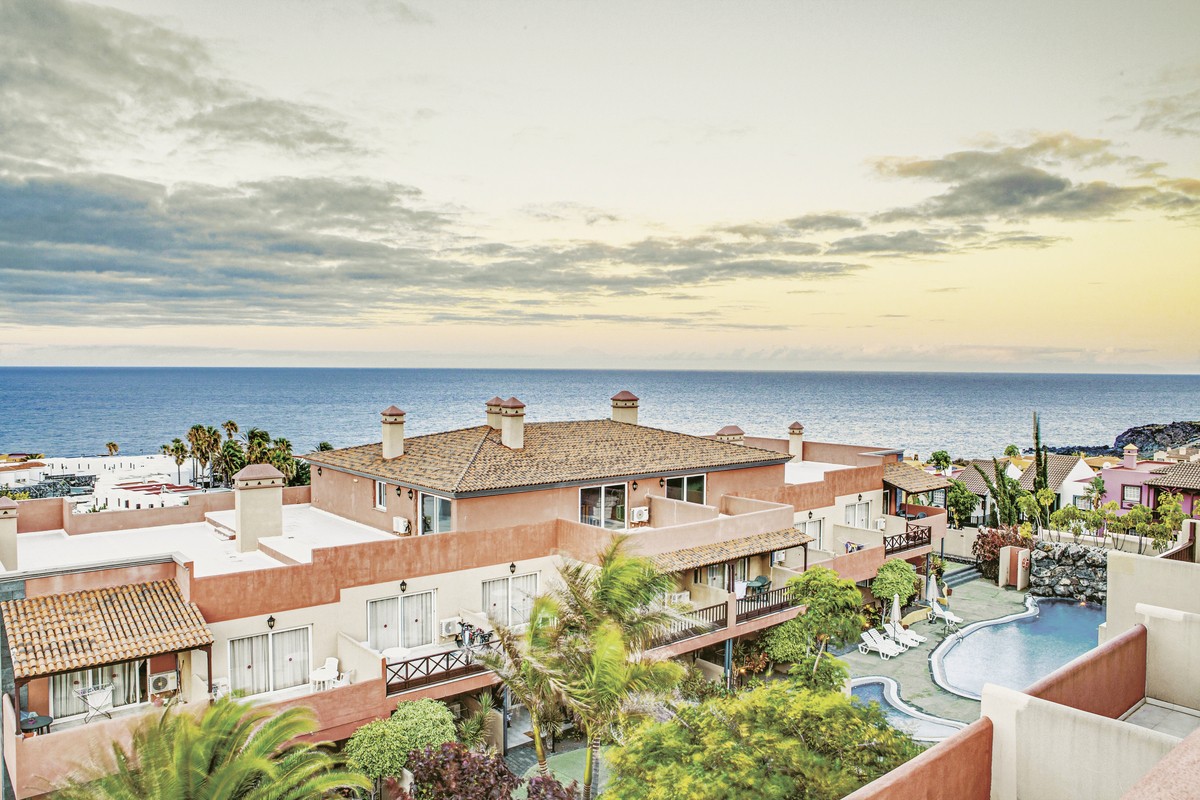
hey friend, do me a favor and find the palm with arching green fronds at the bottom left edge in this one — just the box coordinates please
[55,698,371,800]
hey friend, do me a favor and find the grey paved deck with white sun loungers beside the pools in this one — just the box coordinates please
[839,578,1025,722]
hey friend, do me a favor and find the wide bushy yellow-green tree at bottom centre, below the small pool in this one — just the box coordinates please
[605,681,920,800]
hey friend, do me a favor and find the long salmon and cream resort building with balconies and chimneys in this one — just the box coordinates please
[0,392,946,799]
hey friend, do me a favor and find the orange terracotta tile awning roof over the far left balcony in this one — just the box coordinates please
[0,581,212,680]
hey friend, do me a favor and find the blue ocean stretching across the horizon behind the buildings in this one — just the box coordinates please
[0,367,1200,457]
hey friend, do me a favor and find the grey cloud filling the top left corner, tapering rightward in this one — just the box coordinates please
[0,0,359,166]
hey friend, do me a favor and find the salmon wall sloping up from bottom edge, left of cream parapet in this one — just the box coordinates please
[845,717,992,800]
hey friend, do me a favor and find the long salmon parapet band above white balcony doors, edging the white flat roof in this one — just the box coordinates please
[191,522,558,622]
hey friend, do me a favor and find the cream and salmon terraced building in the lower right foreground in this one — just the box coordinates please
[847,521,1200,800]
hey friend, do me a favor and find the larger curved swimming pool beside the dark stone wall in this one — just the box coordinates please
[930,597,1104,699]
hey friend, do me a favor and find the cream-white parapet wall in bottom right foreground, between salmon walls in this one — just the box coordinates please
[980,684,1181,800]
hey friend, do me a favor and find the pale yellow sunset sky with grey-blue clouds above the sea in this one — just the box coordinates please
[0,0,1200,373]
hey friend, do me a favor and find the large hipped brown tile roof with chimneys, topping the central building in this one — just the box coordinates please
[304,420,790,494]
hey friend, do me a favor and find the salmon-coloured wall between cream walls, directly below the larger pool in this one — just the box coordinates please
[1025,625,1146,720]
